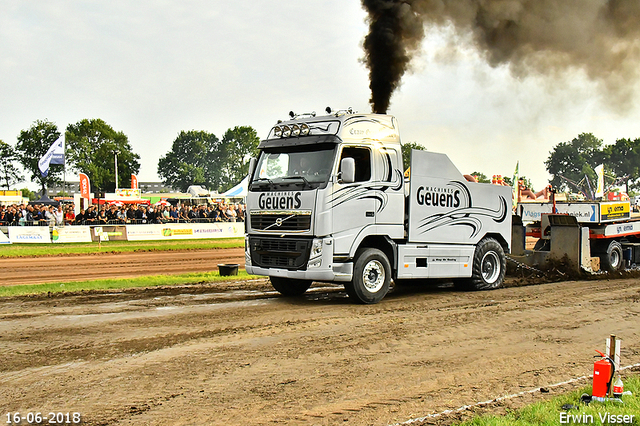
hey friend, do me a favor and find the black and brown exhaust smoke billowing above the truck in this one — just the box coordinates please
[362,0,640,113]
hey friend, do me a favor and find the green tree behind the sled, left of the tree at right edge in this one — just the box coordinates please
[544,133,604,194]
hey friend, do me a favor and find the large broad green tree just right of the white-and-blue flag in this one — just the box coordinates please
[65,119,140,192]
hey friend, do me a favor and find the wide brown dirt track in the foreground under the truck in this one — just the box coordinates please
[0,250,640,425]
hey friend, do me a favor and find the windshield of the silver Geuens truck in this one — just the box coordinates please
[251,144,335,190]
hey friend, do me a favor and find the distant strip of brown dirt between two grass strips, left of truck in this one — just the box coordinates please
[0,248,244,285]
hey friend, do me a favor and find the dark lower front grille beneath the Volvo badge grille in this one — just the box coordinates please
[249,237,311,269]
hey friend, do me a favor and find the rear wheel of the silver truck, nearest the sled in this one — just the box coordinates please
[469,238,507,290]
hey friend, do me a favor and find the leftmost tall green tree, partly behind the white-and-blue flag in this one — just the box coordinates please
[15,120,63,195]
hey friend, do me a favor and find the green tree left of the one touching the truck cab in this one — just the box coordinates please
[158,130,222,192]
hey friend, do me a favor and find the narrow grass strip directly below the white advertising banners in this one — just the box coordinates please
[0,238,244,257]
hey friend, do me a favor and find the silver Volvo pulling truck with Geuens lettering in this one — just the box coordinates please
[245,111,511,303]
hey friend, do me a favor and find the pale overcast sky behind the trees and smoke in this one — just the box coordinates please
[0,0,640,189]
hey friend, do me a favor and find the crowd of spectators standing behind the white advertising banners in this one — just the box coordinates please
[0,203,245,226]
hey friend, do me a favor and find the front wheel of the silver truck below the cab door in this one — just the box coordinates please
[344,248,391,304]
